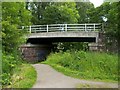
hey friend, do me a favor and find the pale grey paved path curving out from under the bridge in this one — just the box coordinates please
[33,64,118,88]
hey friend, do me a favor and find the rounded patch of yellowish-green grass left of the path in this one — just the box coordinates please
[7,64,37,88]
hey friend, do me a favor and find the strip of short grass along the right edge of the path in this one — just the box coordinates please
[42,62,118,83]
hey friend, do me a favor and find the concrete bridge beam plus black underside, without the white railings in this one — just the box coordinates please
[27,32,98,44]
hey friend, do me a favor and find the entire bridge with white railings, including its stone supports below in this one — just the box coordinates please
[21,23,103,62]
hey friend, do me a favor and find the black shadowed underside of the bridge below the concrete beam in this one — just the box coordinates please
[27,37,96,44]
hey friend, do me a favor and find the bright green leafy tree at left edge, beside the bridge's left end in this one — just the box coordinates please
[2,2,31,52]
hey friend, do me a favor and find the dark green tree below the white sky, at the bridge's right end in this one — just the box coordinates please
[87,2,119,38]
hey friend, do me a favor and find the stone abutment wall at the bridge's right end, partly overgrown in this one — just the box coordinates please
[89,33,118,53]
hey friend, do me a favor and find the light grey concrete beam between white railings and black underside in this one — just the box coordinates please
[28,31,99,38]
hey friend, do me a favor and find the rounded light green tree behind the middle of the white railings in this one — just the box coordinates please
[43,2,79,24]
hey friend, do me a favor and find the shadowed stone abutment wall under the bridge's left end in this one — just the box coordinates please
[20,44,50,63]
